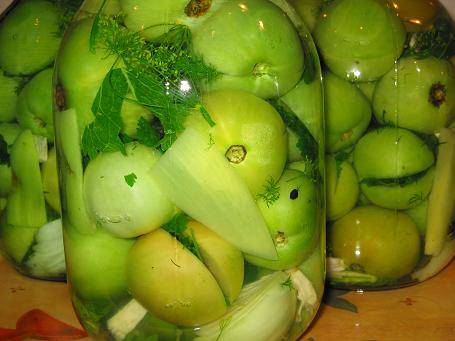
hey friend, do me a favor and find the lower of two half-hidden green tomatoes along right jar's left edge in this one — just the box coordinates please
[325,155,360,220]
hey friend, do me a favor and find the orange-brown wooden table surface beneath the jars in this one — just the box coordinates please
[0,258,455,341]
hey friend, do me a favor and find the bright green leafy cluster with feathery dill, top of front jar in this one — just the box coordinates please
[91,15,219,151]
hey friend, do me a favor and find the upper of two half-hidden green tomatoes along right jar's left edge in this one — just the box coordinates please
[324,72,371,153]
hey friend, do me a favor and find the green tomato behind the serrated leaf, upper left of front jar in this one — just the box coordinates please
[56,19,153,137]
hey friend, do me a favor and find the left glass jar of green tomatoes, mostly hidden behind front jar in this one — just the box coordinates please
[0,0,77,280]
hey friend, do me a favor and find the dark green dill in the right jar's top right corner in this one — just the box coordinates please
[403,15,455,59]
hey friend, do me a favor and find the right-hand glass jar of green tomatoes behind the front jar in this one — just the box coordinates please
[304,0,455,289]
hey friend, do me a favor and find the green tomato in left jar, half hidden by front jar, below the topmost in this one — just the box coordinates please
[17,69,54,141]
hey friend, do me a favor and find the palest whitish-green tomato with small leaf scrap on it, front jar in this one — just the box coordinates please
[84,143,175,238]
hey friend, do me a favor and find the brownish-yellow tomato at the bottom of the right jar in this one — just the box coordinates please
[328,206,420,280]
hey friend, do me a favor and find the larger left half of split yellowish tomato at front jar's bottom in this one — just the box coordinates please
[127,229,227,326]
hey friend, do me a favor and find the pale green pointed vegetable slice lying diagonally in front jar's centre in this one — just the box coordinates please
[152,128,277,259]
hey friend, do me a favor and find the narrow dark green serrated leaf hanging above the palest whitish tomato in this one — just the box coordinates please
[82,69,128,160]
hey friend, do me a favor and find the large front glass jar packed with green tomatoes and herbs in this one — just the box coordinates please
[54,0,325,341]
